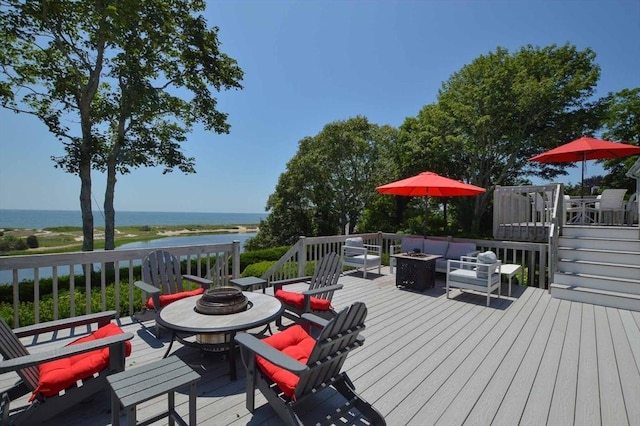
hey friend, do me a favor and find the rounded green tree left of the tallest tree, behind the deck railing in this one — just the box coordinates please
[249,116,395,248]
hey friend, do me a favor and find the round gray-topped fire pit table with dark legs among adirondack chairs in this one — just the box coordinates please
[157,292,284,380]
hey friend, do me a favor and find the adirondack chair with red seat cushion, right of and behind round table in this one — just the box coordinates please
[272,253,342,326]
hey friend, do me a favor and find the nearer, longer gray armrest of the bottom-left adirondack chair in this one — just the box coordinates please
[0,333,133,374]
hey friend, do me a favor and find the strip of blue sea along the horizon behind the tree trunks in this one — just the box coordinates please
[0,209,267,229]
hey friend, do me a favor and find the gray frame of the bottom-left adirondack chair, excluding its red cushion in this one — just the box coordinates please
[0,311,133,425]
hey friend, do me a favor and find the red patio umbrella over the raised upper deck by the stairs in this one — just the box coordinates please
[529,136,640,195]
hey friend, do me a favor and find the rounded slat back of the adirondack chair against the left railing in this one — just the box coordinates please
[142,250,182,294]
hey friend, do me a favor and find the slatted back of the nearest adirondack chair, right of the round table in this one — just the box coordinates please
[295,302,367,395]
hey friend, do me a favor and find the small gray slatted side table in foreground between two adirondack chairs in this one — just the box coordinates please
[107,356,200,426]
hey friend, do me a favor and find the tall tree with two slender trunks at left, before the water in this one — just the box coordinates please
[0,0,243,250]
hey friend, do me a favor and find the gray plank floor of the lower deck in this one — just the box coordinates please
[5,269,640,426]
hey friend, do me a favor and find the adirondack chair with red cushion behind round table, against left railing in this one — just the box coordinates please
[134,250,212,337]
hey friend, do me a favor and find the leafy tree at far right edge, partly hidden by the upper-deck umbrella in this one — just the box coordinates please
[602,87,640,192]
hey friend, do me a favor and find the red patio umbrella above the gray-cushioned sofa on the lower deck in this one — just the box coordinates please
[376,172,487,235]
